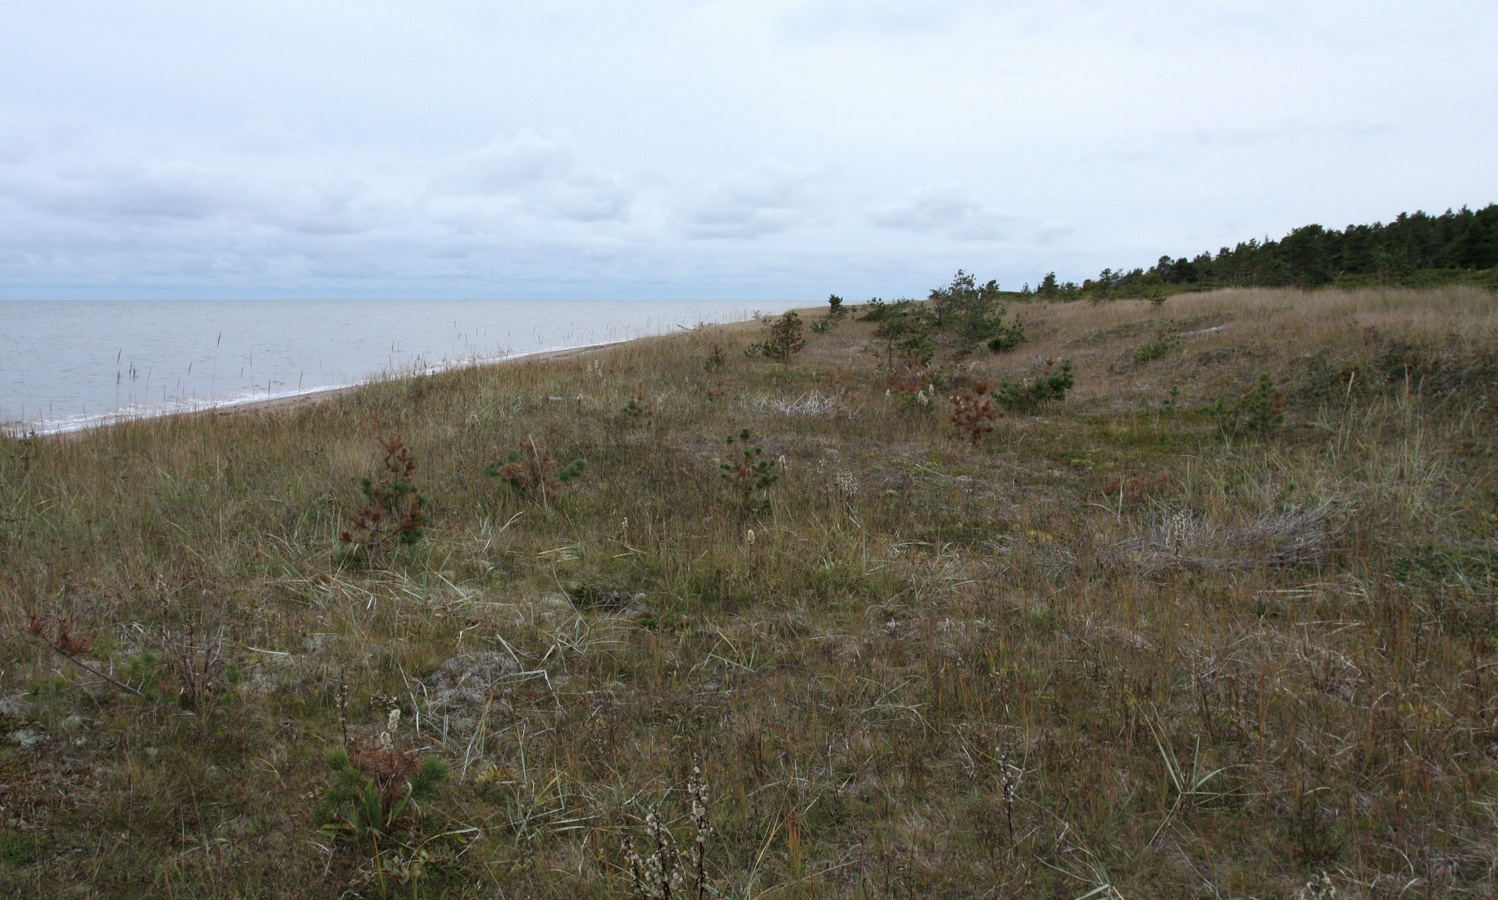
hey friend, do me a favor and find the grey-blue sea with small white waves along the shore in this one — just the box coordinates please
[0,300,797,433]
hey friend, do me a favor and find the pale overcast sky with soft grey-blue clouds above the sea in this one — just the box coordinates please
[0,0,1498,302]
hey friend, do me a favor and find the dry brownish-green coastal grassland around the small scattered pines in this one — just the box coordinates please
[0,288,1498,897]
